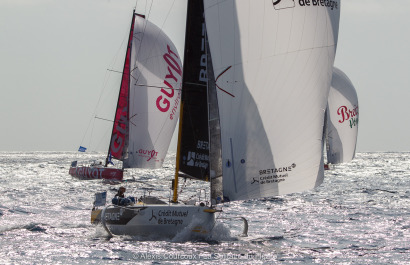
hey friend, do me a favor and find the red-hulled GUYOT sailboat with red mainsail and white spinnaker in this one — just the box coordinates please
[69,10,182,180]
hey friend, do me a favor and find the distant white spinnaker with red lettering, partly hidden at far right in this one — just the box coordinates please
[326,67,359,164]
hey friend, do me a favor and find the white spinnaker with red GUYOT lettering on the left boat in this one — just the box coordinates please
[124,16,182,168]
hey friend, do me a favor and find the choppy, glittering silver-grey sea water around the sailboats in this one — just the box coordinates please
[0,152,410,264]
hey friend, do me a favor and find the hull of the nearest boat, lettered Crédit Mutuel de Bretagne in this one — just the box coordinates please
[92,204,215,238]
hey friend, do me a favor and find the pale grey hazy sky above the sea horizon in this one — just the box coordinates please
[0,0,410,152]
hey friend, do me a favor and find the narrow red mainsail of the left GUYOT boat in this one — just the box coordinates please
[109,13,135,160]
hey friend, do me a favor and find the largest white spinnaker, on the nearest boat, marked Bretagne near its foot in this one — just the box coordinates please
[204,0,340,201]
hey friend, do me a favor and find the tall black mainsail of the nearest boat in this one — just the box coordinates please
[179,0,209,181]
